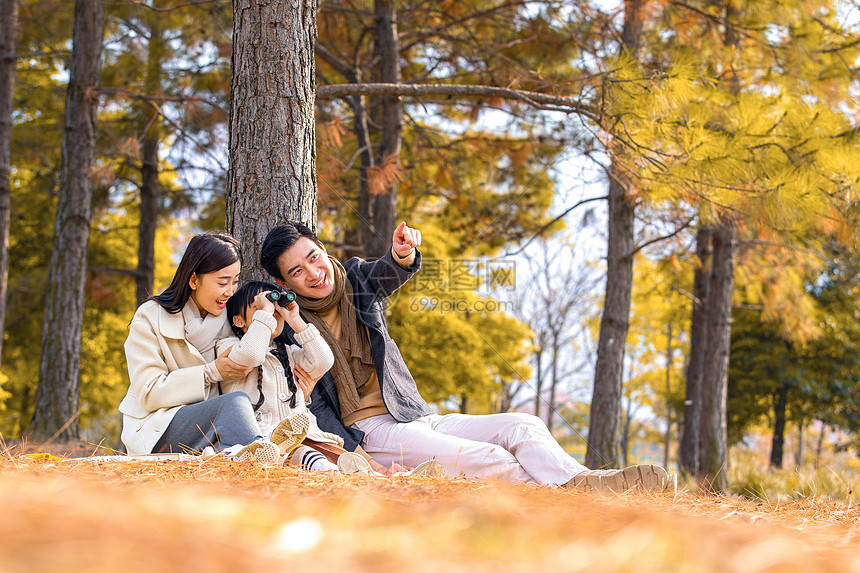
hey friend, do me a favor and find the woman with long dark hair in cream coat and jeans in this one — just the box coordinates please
[119,233,280,463]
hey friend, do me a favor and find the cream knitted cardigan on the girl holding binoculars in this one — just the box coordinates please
[216,310,343,446]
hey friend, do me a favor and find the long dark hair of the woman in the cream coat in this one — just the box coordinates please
[152,233,242,314]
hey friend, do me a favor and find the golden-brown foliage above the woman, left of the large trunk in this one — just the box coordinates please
[99,3,232,214]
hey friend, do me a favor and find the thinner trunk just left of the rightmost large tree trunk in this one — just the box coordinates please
[678,227,711,476]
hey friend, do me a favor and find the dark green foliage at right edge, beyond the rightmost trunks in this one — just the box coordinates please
[728,244,860,442]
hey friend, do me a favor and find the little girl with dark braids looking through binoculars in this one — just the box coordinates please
[216,282,371,473]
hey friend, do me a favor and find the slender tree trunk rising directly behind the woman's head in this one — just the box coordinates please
[135,14,164,305]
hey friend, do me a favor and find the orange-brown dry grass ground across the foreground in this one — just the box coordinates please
[0,446,860,573]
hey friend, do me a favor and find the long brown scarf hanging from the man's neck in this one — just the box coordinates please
[296,255,376,418]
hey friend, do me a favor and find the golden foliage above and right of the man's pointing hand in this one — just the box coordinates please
[317,0,576,412]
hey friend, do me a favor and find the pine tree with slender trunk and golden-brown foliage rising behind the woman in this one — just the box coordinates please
[100,2,229,303]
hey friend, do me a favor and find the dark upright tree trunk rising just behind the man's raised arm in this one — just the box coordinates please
[364,0,403,258]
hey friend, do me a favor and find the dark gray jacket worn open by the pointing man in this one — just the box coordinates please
[287,249,432,451]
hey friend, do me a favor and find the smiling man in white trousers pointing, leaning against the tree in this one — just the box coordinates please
[260,222,668,491]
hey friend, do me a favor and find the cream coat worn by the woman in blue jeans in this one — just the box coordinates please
[119,300,230,455]
